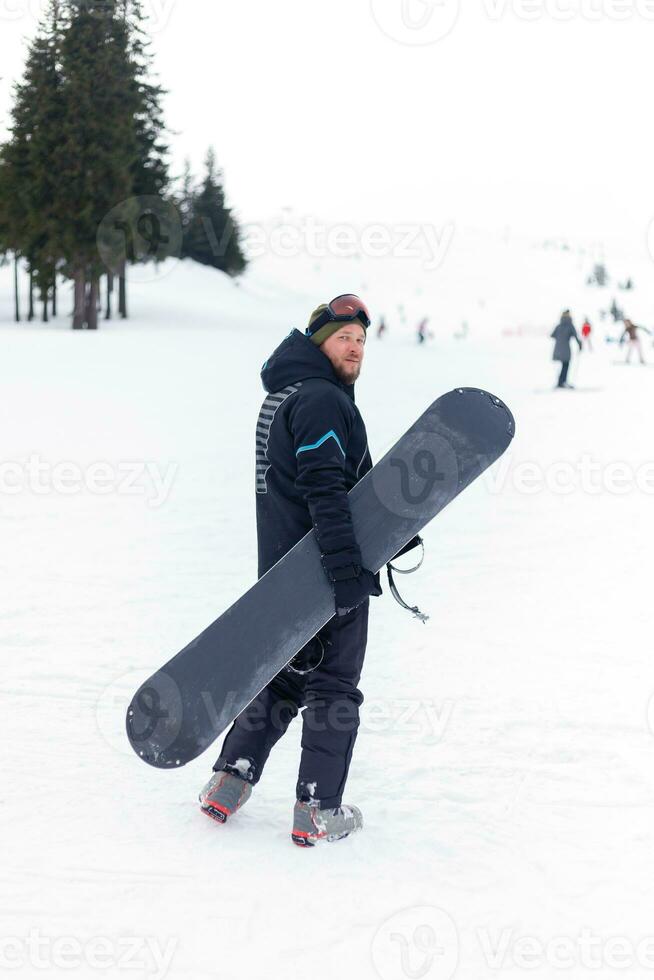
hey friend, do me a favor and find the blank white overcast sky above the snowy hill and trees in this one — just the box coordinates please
[0,0,654,253]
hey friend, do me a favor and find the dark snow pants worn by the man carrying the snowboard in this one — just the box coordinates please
[213,599,369,809]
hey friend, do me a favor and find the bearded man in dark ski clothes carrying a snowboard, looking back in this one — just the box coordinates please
[200,294,381,846]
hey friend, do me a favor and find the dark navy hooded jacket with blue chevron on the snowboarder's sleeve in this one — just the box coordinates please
[256,330,372,576]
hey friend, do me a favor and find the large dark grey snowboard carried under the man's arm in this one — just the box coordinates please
[127,388,515,769]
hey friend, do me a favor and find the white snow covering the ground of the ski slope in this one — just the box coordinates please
[0,249,654,980]
